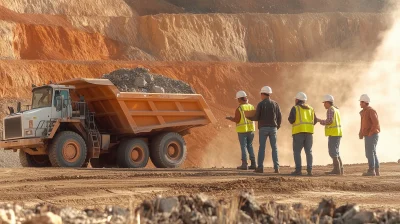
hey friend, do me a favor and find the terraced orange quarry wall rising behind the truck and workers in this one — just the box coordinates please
[0,0,391,167]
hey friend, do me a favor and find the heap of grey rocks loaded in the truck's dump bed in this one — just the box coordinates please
[102,67,195,94]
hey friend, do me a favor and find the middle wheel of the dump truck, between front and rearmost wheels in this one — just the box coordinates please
[117,139,150,168]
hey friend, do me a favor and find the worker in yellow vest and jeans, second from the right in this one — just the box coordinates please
[317,95,344,175]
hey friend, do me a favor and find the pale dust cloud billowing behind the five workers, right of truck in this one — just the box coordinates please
[202,3,400,167]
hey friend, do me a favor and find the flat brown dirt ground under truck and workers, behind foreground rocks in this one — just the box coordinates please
[0,163,400,208]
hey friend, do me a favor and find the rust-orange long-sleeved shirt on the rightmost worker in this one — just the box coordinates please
[359,107,381,136]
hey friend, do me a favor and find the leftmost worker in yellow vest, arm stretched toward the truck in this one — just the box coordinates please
[227,91,256,170]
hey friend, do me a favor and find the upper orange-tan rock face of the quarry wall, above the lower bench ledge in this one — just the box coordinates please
[0,13,389,62]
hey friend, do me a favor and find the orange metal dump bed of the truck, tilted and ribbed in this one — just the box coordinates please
[59,79,215,134]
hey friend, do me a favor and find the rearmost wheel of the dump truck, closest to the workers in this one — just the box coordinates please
[150,132,187,168]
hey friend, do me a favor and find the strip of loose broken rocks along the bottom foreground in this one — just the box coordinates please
[0,192,400,224]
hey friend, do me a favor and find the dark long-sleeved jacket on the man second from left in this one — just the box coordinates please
[249,99,282,129]
